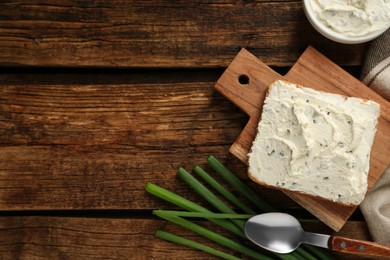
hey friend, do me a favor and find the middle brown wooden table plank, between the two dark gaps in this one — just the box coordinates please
[0,81,304,210]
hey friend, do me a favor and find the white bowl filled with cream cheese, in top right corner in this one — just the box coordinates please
[304,0,390,43]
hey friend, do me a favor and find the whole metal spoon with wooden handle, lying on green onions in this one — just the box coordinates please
[245,213,390,256]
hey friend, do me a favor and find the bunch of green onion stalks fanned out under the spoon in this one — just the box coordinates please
[145,156,332,260]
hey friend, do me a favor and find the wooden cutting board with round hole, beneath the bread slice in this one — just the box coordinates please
[215,47,390,231]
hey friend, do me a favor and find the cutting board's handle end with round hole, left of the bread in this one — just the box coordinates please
[215,49,282,163]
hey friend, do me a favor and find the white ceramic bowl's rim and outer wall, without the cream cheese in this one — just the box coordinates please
[303,0,390,44]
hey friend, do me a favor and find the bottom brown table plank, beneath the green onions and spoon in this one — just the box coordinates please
[0,216,369,259]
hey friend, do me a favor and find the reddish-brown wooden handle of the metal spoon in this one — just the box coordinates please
[329,236,390,256]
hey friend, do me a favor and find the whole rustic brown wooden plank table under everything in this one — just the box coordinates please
[0,0,378,259]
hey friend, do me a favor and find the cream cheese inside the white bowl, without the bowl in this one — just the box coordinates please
[311,0,390,37]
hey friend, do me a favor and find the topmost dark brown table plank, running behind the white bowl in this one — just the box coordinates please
[0,0,366,68]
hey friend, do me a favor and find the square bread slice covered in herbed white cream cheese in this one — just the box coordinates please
[248,81,380,205]
